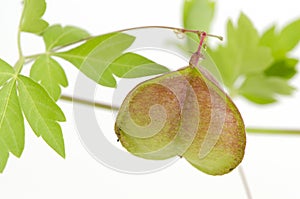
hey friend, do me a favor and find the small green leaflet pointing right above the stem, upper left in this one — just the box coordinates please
[43,25,89,51]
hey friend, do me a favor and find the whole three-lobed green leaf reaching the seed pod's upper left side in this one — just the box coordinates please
[55,32,168,87]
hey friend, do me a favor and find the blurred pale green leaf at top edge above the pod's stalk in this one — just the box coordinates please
[183,0,215,32]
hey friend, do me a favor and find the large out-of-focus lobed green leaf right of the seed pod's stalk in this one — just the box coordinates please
[209,14,298,104]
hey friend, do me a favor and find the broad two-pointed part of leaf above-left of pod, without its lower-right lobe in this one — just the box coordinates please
[55,33,135,87]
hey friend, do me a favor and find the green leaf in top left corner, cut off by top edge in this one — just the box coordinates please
[20,0,48,34]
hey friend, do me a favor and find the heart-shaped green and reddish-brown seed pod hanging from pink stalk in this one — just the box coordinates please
[115,66,246,175]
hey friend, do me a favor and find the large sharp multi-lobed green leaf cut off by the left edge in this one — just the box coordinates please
[0,59,65,172]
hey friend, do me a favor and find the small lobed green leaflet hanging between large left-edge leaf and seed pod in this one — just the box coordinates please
[30,55,68,101]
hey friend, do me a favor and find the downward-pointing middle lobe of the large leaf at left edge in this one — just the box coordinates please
[0,80,25,157]
